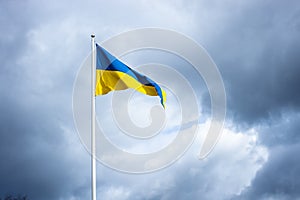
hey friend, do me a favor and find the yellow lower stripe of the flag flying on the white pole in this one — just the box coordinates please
[95,69,162,100]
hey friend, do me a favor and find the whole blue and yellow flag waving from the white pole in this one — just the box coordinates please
[95,44,166,107]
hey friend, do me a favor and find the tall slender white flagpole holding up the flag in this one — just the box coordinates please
[91,35,97,200]
